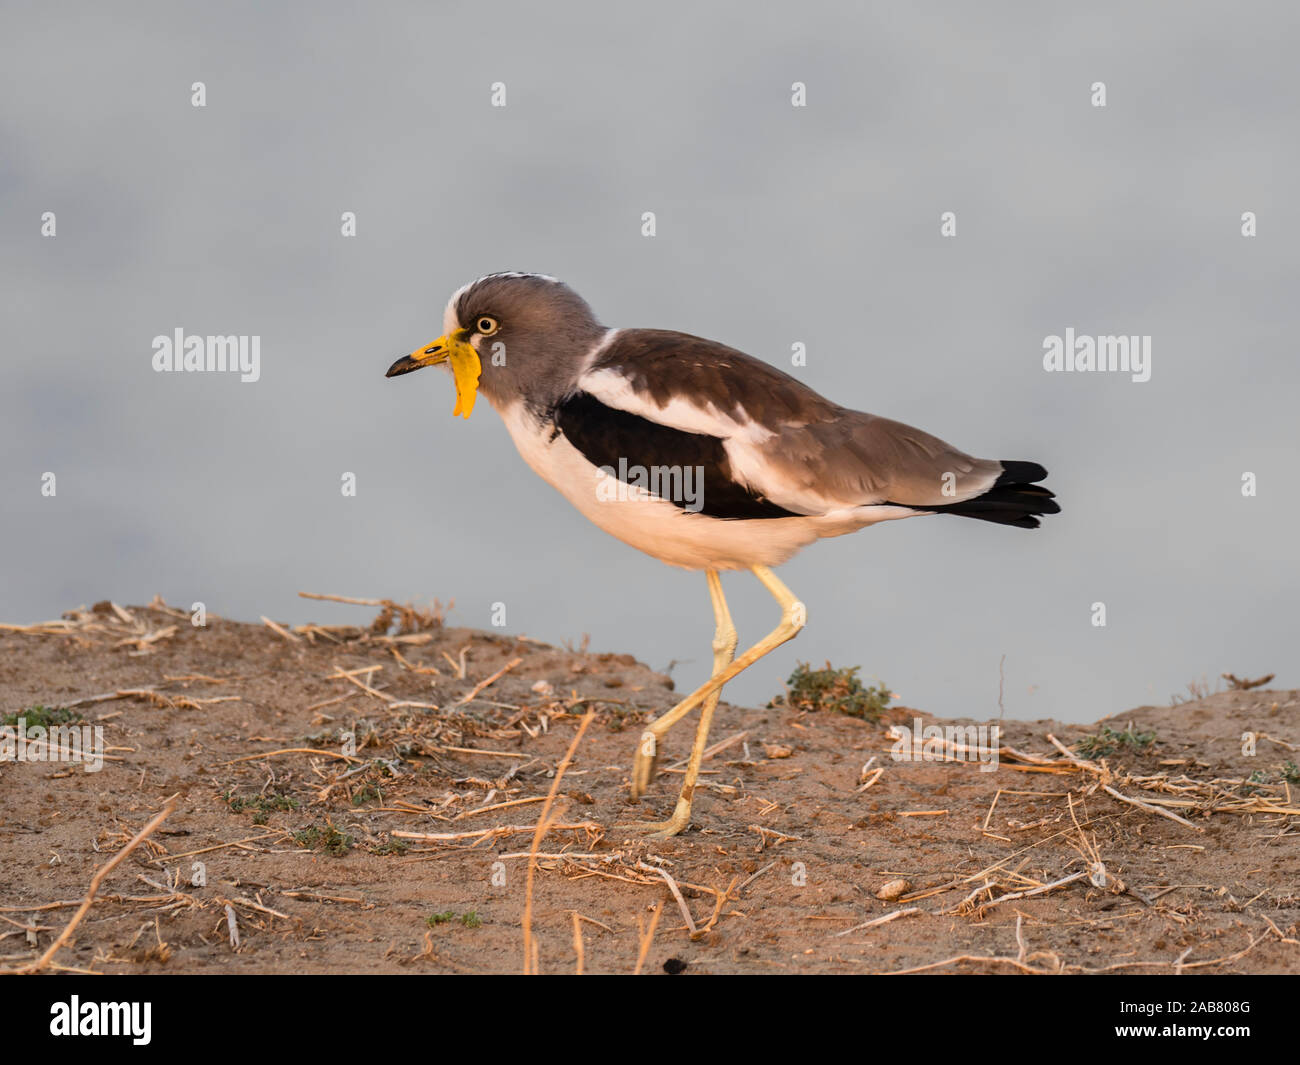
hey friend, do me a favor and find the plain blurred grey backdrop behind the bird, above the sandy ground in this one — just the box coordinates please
[0,3,1300,720]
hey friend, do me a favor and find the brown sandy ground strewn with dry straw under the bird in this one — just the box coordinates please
[0,605,1300,974]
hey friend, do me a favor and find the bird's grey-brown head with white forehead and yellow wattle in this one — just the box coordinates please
[385,273,605,417]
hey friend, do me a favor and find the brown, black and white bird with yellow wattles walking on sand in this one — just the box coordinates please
[385,272,1060,839]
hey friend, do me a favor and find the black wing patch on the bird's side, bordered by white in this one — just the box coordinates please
[554,391,800,519]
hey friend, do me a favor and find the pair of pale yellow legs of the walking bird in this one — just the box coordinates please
[627,566,807,837]
